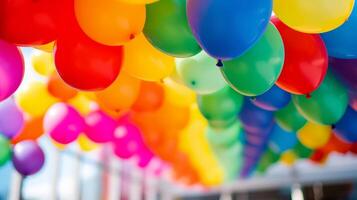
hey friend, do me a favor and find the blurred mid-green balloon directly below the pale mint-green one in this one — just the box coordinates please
[197,86,243,129]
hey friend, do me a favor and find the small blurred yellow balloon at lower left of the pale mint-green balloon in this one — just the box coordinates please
[164,79,196,107]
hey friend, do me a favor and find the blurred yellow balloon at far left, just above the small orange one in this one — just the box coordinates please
[15,82,58,117]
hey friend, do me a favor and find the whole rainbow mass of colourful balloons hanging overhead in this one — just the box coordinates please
[0,0,357,186]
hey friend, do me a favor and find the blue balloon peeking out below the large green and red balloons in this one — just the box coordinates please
[251,85,291,111]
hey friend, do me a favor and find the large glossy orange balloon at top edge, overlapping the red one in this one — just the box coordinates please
[74,0,146,46]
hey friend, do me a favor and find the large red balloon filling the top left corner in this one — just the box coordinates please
[0,0,56,46]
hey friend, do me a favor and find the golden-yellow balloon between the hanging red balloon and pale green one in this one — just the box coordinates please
[123,34,175,81]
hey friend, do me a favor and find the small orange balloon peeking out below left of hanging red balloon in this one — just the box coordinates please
[47,72,78,101]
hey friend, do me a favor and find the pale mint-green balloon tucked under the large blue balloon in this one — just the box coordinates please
[176,51,227,94]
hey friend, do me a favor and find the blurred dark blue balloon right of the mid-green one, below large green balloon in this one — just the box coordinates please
[239,100,274,134]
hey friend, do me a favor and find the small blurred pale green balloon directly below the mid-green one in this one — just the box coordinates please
[206,120,242,148]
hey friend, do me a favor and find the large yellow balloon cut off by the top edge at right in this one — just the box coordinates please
[273,0,354,33]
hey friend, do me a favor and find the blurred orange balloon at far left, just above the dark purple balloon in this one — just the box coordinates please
[11,117,44,144]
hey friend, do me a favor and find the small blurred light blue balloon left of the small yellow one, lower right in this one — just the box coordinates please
[269,125,298,154]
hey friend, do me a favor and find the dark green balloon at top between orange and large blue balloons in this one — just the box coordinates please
[144,0,201,57]
